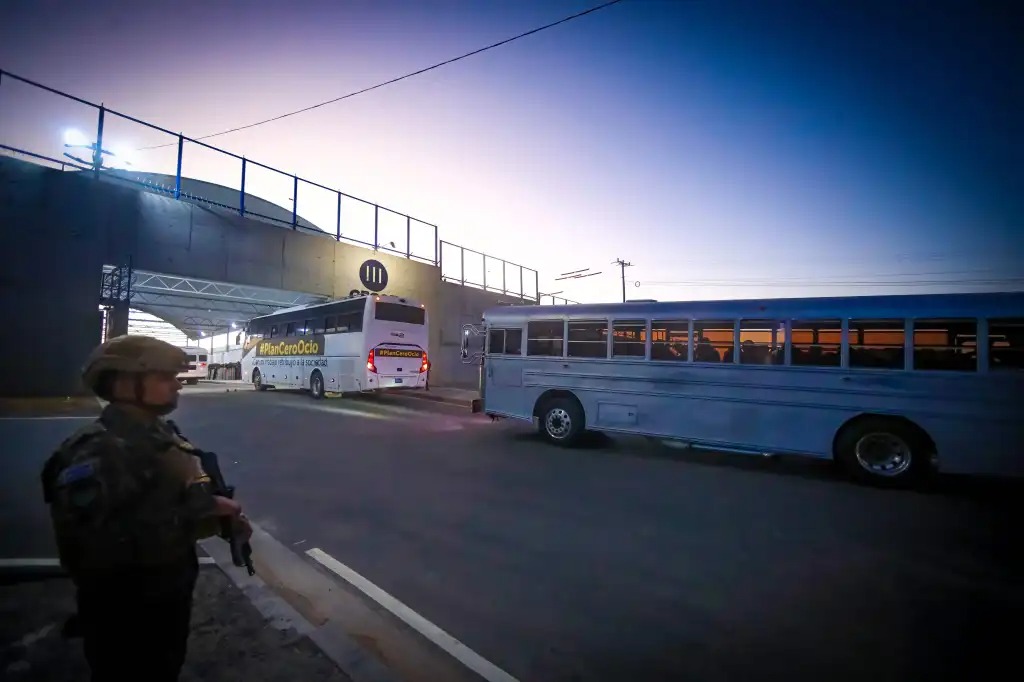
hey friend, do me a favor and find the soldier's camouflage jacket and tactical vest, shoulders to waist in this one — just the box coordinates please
[42,411,212,576]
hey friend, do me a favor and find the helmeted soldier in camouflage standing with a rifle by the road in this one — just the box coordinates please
[42,336,252,682]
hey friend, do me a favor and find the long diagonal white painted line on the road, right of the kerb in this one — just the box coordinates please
[306,547,518,682]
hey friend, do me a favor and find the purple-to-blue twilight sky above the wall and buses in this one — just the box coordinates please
[0,0,1024,301]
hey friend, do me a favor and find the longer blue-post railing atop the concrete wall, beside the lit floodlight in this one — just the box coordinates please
[0,70,448,266]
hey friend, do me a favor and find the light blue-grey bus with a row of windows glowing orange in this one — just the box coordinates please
[463,293,1024,486]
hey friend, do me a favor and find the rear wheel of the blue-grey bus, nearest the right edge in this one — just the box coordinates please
[834,417,931,488]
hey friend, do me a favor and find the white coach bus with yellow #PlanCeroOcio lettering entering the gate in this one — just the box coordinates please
[242,295,430,398]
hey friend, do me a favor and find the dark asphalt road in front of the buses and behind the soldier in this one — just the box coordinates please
[0,390,1024,682]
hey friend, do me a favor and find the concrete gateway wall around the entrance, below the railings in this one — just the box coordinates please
[0,158,521,396]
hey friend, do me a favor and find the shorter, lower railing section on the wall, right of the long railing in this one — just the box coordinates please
[437,240,540,301]
